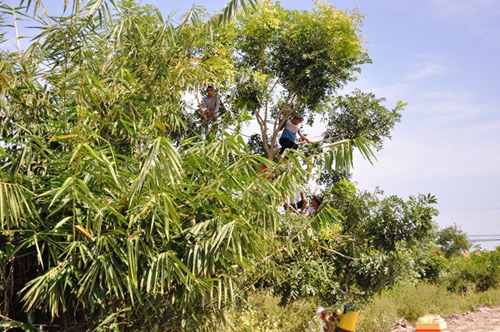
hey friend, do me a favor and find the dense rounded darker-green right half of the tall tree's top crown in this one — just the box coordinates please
[266,4,369,106]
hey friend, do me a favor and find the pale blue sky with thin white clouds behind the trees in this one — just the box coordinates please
[5,0,500,249]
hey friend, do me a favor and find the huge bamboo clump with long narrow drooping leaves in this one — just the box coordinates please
[0,0,376,330]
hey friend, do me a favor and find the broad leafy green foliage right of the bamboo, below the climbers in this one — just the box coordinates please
[276,181,437,304]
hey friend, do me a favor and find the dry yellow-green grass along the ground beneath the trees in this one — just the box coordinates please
[214,283,500,332]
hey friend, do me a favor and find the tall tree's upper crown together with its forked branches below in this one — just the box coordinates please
[230,1,376,159]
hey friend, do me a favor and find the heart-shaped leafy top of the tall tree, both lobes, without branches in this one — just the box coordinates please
[237,3,368,105]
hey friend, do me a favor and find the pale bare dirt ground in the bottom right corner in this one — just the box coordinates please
[391,307,500,332]
